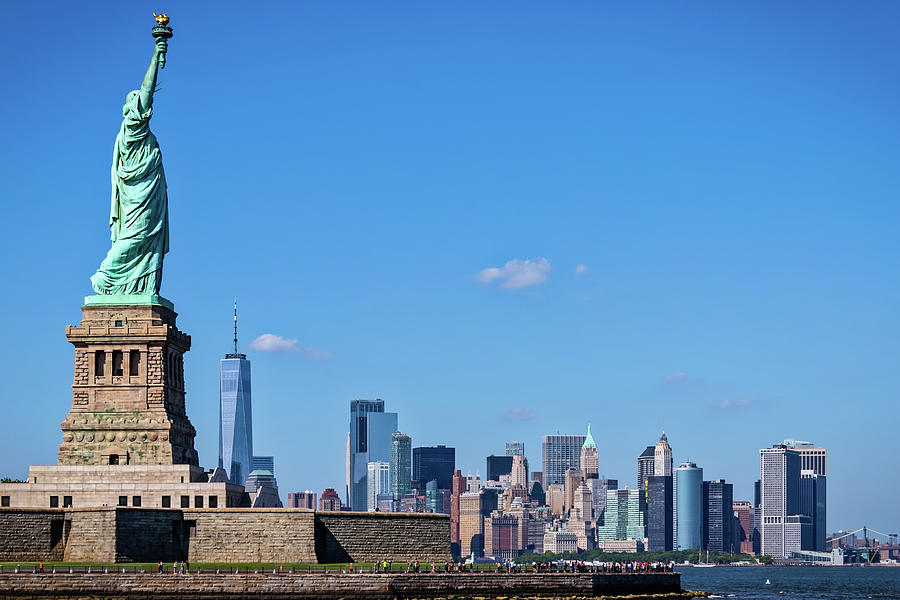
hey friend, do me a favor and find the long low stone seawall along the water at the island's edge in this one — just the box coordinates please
[0,573,693,600]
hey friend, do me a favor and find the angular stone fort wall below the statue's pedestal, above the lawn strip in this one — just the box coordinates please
[0,507,450,564]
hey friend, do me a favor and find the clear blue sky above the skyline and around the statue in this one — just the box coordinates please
[0,2,900,531]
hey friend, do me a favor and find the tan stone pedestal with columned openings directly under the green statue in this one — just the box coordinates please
[58,304,198,465]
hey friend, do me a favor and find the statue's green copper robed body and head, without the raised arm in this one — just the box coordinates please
[91,91,169,294]
